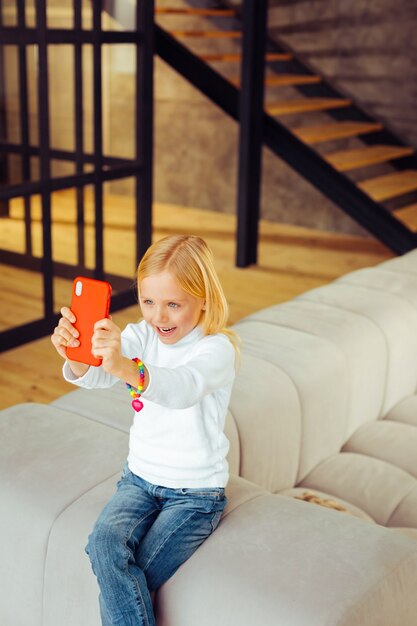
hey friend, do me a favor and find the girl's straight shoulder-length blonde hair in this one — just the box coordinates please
[138,235,239,353]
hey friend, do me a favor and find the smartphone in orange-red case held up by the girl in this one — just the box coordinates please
[66,276,111,367]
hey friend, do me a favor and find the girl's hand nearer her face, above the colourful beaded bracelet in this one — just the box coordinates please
[91,318,126,378]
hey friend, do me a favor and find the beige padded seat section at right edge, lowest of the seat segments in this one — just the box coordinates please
[298,452,417,528]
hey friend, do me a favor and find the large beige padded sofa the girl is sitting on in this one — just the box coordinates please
[0,251,417,626]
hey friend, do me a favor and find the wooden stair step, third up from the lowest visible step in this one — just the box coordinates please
[324,146,414,172]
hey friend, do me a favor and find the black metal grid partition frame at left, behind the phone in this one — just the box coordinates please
[0,0,154,351]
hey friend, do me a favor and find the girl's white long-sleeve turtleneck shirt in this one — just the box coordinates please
[63,321,235,488]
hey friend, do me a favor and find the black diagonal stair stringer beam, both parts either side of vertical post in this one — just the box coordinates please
[155,25,417,258]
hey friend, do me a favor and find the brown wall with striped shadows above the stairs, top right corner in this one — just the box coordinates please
[269,0,417,147]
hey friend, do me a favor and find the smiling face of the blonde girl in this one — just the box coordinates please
[139,271,204,344]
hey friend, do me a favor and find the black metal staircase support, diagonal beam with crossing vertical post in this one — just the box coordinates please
[155,0,417,267]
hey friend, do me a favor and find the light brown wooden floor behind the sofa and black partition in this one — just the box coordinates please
[0,194,393,408]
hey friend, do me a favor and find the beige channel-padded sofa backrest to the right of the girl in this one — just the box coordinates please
[230,251,417,492]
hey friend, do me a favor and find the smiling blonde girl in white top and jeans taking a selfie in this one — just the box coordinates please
[52,235,237,626]
